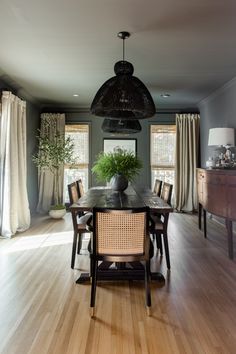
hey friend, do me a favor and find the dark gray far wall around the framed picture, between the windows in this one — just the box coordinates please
[66,113,175,186]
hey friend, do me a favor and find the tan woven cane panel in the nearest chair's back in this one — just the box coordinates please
[97,213,145,255]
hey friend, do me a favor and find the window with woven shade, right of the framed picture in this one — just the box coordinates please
[150,125,176,188]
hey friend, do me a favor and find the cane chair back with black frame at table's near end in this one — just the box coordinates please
[93,208,149,262]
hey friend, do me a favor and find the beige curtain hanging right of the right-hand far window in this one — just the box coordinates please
[175,114,200,212]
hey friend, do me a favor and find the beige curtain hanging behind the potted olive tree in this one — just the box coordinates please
[37,113,65,213]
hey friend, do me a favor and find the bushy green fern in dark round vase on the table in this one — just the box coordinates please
[92,149,142,192]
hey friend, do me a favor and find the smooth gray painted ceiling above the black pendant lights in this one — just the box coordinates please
[0,0,236,110]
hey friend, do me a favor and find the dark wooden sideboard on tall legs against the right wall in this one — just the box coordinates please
[197,168,236,259]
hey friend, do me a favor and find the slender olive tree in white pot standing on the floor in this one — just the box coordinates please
[33,126,75,219]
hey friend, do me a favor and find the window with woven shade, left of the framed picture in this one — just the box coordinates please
[64,124,89,203]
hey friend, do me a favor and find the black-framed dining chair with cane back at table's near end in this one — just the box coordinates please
[90,207,151,317]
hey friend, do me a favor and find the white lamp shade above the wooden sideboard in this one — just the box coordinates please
[208,128,235,146]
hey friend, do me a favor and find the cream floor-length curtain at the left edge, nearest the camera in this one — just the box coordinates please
[0,91,30,237]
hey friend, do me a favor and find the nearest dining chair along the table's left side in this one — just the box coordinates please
[67,181,92,269]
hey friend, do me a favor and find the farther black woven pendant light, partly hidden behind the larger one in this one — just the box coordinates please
[102,118,142,134]
